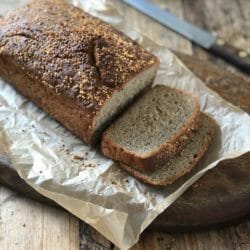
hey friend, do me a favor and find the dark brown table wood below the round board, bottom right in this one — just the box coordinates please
[132,221,250,250]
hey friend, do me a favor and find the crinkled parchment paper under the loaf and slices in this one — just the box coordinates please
[0,0,250,249]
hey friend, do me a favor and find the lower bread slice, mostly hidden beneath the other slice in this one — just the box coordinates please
[120,114,215,186]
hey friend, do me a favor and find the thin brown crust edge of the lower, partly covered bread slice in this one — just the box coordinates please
[119,113,215,186]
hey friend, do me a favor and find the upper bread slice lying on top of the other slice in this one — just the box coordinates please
[102,85,200,171]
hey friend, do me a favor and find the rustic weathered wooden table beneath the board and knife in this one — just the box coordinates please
[0,0,250,250]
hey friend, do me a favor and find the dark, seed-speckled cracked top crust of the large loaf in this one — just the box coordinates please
[0,0,159,143]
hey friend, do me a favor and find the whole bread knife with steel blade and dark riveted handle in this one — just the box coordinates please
[123,0,250,74]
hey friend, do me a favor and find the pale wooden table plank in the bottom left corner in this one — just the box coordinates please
[0,187,79,250]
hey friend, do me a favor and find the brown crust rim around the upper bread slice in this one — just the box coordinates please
[102,85,201,171]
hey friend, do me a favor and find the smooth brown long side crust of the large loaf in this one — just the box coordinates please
[0,57,92,141]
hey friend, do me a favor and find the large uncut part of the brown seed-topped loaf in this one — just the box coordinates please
[0,0,159,144]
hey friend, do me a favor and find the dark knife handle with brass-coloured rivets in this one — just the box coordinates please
[208,39,250,74]
